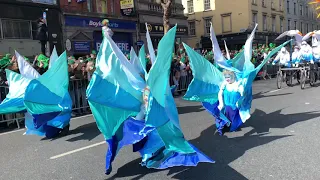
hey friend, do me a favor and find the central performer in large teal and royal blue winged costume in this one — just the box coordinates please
[87,26,213,174]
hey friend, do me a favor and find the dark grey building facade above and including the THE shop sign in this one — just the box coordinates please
[136,0,188,48]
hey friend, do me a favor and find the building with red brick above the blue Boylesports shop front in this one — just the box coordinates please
[60,0,138,56]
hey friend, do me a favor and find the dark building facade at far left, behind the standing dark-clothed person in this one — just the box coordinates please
[0,0,63,56]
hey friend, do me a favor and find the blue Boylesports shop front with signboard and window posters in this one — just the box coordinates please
[64,16,136,56]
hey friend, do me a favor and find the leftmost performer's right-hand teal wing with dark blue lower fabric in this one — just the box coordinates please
[24,52,72,138]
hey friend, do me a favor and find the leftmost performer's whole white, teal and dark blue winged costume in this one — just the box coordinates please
[0,49,72,138]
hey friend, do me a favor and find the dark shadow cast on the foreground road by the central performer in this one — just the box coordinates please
[108,126,288,180]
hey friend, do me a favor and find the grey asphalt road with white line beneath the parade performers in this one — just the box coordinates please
[0,80,320,180]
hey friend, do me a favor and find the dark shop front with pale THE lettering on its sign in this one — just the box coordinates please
[140,23,188,50]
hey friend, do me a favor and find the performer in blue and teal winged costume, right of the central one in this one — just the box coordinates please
[184,25,289,135]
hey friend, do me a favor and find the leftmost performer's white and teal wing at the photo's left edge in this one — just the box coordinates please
[0,69,31,114]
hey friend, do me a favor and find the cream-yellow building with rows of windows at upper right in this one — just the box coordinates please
[183,0,316,49]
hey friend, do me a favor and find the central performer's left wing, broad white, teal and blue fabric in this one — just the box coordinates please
[86,37,144,139]
